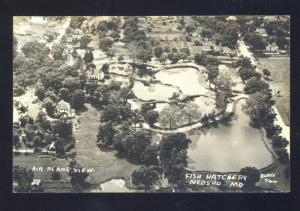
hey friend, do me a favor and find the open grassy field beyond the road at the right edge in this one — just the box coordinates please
[258,57,290,126]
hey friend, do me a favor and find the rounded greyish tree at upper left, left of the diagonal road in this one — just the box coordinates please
[21,41,50,61]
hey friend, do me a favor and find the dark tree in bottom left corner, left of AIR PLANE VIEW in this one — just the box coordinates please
[13,166,34,192]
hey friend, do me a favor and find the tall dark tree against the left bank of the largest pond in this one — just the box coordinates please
[159,133,191,184]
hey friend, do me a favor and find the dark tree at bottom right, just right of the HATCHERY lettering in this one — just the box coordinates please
[239,167,260,190]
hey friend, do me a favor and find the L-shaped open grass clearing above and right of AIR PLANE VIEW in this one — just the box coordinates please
[74,104,139,185]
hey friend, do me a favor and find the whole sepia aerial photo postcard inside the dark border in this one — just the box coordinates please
[11,15,290,193]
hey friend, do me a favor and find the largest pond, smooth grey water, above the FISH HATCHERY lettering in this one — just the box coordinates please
[188,100,273,172]
